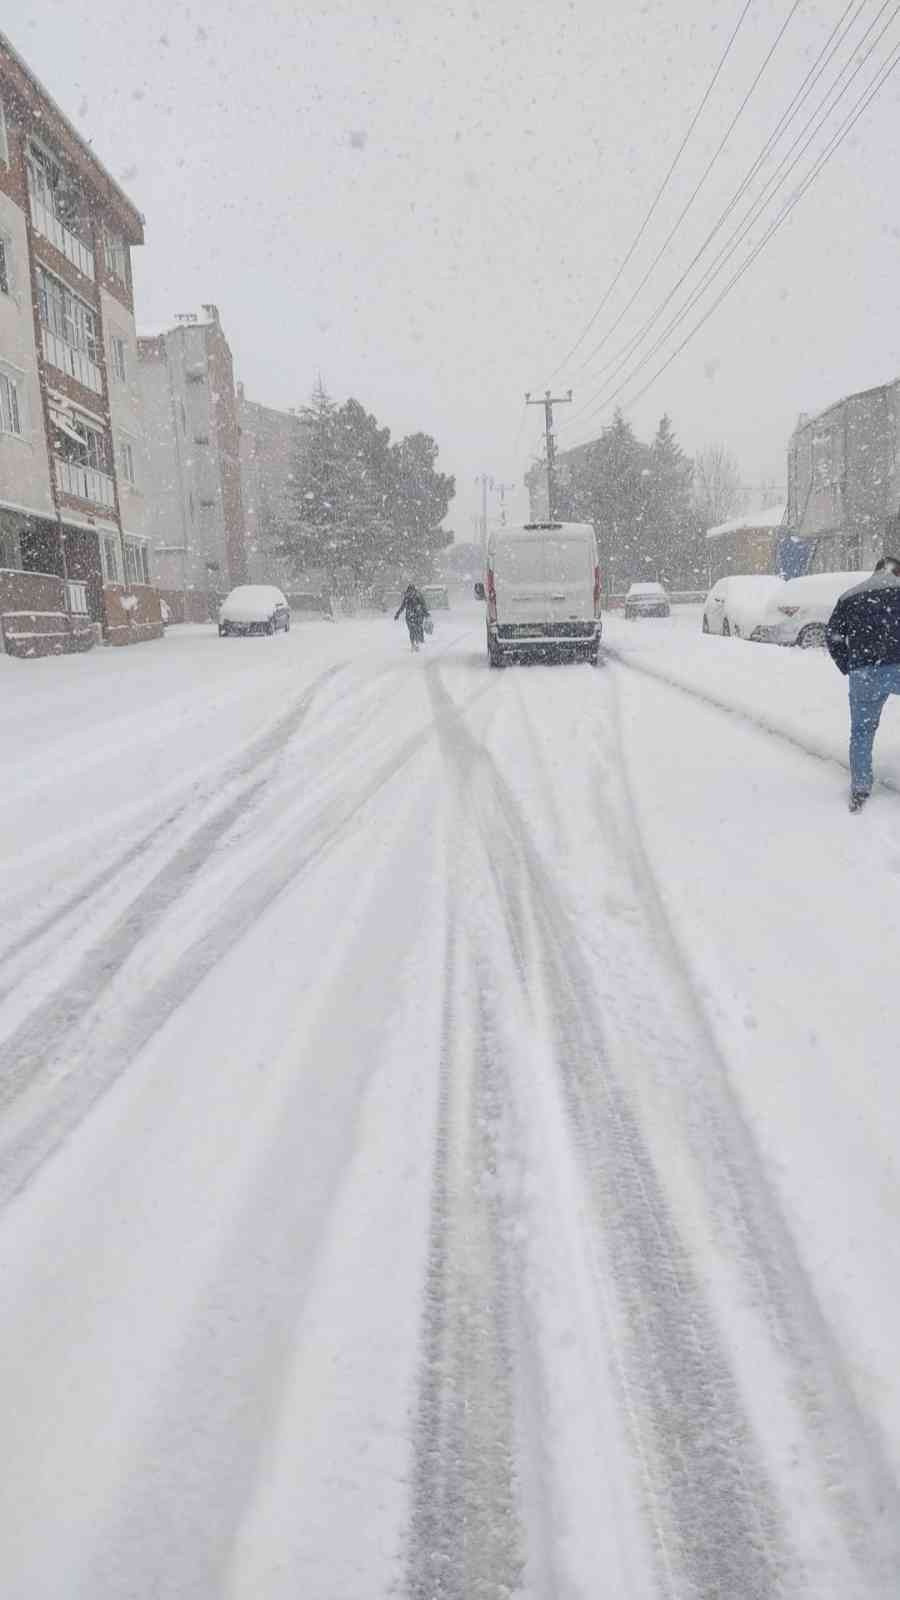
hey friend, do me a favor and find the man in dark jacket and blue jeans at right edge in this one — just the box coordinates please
[825,555,900,811]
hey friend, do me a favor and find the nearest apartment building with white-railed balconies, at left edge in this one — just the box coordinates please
[0,34,162,654]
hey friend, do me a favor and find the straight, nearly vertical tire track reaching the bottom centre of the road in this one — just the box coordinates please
[405,864,524,1600]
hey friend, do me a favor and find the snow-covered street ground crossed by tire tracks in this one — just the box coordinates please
[0,608,900,1600]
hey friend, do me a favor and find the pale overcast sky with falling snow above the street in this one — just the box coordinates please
[15,0,900,538]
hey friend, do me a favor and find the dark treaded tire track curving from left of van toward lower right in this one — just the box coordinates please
[419,656,796,1600]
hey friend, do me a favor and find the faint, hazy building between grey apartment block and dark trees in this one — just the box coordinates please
[237,384,304,589]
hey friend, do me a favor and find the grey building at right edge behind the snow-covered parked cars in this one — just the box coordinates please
[788,379,900,573]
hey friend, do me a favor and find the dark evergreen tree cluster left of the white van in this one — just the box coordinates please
[279,384,455,587]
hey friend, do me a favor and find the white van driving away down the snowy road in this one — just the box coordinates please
[476,522,601,667]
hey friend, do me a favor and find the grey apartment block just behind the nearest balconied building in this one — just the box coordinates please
[138,306,248,621]
